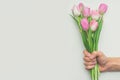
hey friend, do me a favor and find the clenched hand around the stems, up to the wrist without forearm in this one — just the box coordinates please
[83,50,108,72]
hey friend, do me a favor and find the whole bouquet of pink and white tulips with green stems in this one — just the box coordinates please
[71,3,108,80]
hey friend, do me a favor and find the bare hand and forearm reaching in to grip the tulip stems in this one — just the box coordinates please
[83,50,120,72]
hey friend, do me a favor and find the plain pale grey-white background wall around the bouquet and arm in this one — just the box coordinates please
[0,0,120,80]
